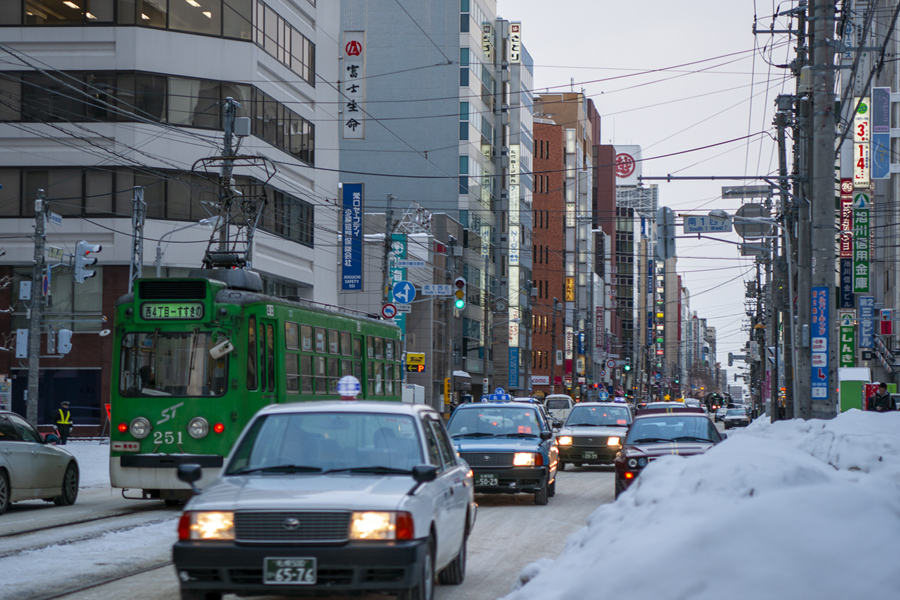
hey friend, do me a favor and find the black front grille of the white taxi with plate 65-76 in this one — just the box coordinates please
[234,511,350,543]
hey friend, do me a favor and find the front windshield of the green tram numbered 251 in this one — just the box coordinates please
[119,331,228,397]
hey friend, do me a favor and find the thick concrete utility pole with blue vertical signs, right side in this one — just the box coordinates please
[800,0,838,419]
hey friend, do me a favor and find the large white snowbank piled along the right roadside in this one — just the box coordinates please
[505,410,900,600]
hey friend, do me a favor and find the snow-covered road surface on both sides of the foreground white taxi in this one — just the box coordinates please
[0,468,614,600]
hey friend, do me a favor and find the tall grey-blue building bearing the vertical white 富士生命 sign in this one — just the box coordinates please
[340,0,533,396]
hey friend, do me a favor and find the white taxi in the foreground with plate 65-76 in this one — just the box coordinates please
[173,401,477,600]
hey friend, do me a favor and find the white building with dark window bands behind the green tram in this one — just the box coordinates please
[0,0,339,434]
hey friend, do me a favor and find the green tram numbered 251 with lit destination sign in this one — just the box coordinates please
[109,269,402,503]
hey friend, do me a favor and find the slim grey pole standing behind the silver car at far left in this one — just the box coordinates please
[25,190,48,423]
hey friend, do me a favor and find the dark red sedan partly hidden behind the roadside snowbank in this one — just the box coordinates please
[615,407,726,498]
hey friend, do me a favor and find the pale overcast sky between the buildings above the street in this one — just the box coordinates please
[506,0,794,381]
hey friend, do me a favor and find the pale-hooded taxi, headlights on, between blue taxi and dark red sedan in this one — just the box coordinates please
[556,402,631,471]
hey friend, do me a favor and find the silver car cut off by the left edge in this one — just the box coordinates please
[0,411,78,514]
